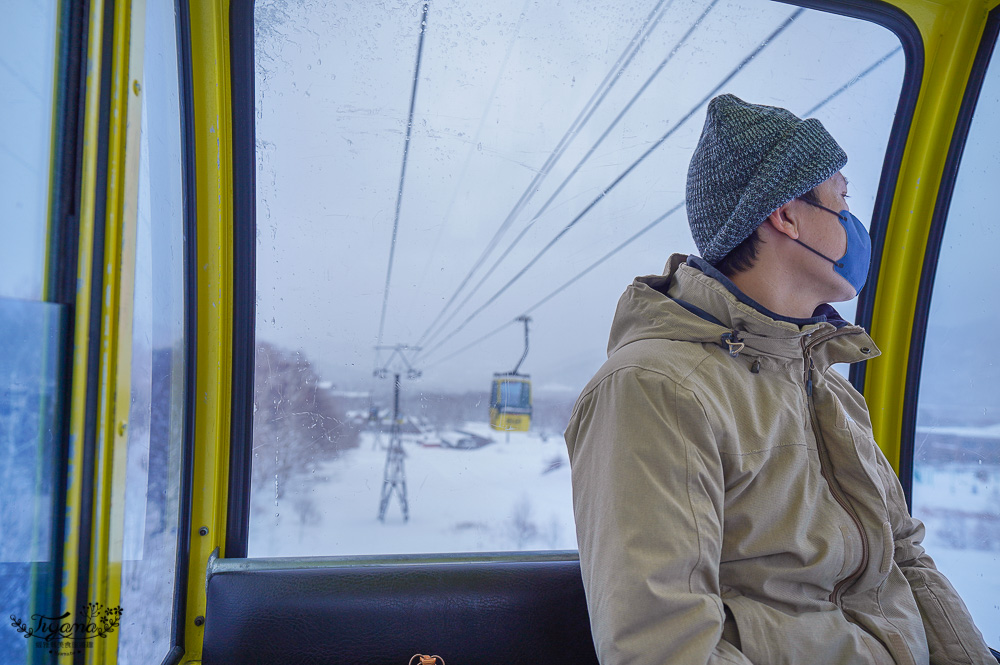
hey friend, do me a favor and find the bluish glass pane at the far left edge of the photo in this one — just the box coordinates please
[0,0,67,664]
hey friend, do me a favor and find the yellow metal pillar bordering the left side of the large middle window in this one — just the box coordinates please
[180,0,232,662]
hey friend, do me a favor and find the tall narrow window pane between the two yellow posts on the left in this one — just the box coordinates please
[118,0,185,664]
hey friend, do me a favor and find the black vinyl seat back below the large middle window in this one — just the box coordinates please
[202,559,597,665]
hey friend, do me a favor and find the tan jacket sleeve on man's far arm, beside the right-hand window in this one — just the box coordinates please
[878,454,997,665]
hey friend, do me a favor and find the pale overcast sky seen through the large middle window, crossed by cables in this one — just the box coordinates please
[256,0,904,400]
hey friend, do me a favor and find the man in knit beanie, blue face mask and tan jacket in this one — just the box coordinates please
[566,95,996,665]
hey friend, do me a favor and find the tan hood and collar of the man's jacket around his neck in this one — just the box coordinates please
[608,254,879,369]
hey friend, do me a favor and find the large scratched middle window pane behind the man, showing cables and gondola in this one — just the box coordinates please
[249,0,904,556]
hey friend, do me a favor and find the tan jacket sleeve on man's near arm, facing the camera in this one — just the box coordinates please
[566,367,750,665]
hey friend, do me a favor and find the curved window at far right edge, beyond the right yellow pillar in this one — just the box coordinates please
[913,28,1000,649]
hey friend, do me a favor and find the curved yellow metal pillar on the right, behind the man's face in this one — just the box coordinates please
[865,0,997,473]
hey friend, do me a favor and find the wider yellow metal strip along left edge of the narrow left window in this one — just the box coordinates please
[86,0,145,663]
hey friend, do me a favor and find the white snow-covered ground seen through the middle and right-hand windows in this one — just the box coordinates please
[250,423,1000,647]
